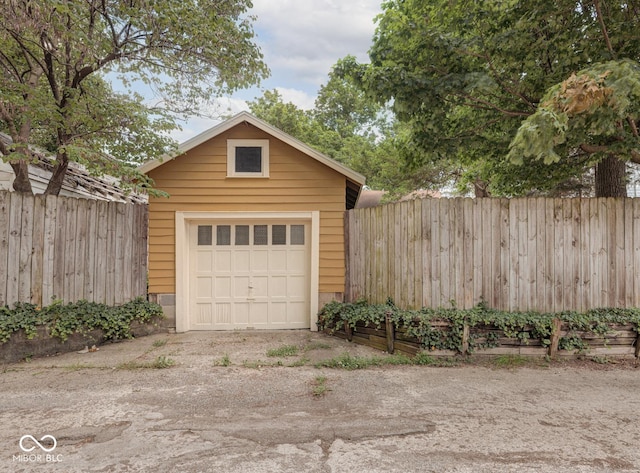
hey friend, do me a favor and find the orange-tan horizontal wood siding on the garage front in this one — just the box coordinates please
[149,124,346,294]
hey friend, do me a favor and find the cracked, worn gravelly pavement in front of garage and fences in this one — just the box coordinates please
[0,331,640,473]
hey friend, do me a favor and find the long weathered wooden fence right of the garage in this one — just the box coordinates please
[345,198,640,312]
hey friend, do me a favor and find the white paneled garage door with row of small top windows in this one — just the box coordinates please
[189,221,310,330]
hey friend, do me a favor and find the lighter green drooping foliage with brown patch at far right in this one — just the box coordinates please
[508,59,640,168]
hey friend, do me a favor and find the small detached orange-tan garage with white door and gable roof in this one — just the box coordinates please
[141,112,364,332]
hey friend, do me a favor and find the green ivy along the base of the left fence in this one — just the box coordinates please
[0,298,164,343]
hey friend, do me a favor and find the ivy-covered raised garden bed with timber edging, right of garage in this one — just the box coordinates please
[318,301,640,358]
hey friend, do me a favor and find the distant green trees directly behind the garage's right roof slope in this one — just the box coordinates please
[249,57,447,198]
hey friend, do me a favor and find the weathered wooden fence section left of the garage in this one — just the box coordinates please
[0,192,148,306]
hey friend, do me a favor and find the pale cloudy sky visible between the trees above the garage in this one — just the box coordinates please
[172,0,382,142]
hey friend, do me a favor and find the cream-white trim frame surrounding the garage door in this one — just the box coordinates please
[175,210,320,332]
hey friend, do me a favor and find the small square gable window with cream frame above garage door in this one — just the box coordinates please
[227,140,269,177]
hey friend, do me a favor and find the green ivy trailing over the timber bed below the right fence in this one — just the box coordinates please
[318,300,640,354]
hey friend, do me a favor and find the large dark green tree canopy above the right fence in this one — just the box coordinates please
[342,0,640,195]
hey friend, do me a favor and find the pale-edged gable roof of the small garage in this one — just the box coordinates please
[138,112,365,186]
